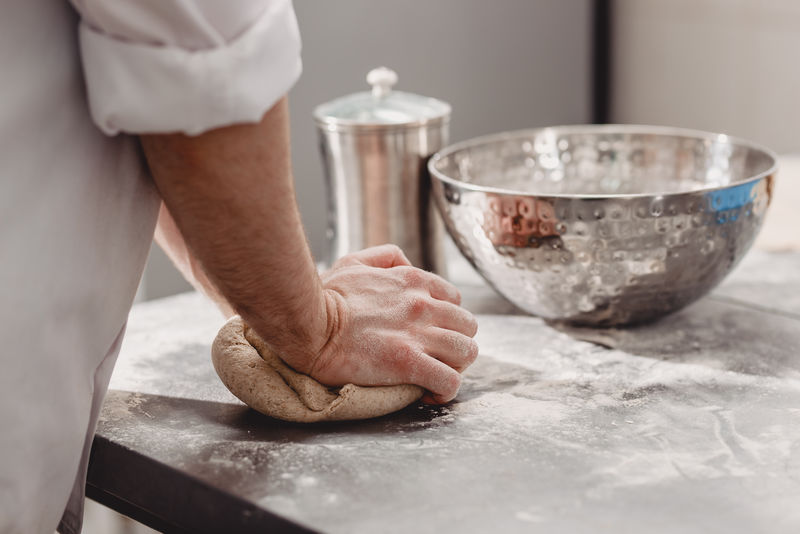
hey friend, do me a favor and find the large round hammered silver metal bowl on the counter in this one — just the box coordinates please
[428,125,776,326]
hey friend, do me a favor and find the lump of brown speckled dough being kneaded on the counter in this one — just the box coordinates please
[211,316,423,423]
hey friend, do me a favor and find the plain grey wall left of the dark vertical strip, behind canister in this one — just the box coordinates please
[141,0,591,299]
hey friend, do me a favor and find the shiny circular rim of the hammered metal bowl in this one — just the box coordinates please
[427,124,778,200]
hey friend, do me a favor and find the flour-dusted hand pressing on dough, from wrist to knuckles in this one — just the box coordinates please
[309,245,478,403]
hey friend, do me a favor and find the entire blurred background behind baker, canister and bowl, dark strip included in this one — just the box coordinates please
[89,0,800,534]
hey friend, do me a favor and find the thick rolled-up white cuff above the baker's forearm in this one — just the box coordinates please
[80,0,302,135]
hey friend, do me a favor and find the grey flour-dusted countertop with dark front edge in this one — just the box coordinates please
[87,250,800,533]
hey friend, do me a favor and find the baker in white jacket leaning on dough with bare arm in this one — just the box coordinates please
[0,0,477,534]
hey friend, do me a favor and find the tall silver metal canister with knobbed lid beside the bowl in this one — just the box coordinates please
[314,67,450,274]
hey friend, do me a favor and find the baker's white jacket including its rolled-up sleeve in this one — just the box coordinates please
[0,0,301,534]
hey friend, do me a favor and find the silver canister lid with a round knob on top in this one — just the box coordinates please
[314,67,450,130]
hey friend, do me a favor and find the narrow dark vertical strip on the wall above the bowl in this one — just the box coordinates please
[592,0,613,124]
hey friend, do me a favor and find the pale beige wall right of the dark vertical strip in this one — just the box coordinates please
[611,0,800,153]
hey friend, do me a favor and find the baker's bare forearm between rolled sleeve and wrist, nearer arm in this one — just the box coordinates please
[142,99,327,369]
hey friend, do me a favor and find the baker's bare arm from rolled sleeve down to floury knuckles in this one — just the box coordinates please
[141,99,477,402]
